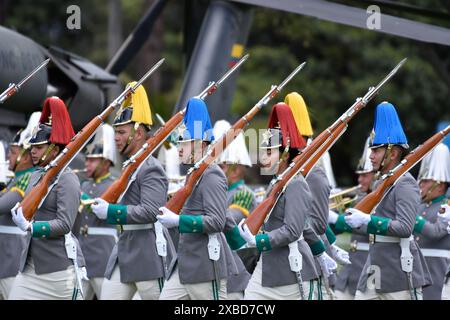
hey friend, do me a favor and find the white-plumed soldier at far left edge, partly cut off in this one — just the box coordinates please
[0,112,41,300]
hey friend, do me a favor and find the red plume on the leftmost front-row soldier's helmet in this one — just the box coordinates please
[39,97,75,145]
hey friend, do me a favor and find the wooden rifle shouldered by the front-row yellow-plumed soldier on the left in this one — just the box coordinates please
[100,54,249,203]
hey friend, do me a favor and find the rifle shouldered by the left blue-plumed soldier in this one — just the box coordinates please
[166,62,306,214]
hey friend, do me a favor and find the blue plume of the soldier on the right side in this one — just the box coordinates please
[372,102,408,145]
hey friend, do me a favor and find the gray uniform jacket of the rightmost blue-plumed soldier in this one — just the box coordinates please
[358,172,431,293]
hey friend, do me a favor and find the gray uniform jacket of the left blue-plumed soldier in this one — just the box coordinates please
[178,164,238,284]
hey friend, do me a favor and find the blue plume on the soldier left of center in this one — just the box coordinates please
[181,98,214,142]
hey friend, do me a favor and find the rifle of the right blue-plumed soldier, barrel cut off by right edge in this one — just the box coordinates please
[355,125,450,214]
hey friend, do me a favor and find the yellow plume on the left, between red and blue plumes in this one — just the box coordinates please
[122,81,153,125]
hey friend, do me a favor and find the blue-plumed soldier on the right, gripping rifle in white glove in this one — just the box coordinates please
[345,102,431,300]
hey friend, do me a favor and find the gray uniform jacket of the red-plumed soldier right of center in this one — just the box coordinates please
[261,176,317,287]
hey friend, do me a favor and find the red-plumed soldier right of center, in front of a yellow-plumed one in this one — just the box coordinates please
[239,103,319,300]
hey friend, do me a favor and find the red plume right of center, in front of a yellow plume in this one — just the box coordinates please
[268,102,306,149]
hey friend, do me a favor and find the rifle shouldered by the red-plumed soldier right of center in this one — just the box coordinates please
[245,58,406,234]
